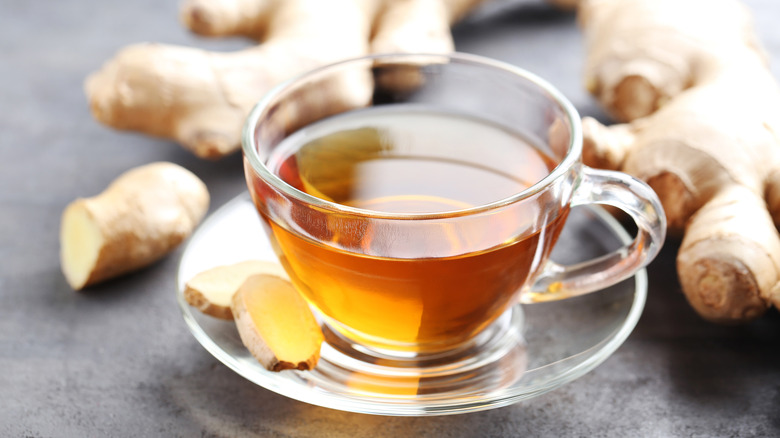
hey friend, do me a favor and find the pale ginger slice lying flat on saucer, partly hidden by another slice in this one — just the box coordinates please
[184,260,287,320]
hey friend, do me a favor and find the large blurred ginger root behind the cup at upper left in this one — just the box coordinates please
[86,0,482,158]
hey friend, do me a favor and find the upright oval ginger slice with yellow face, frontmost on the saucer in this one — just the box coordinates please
[231,274,324,371]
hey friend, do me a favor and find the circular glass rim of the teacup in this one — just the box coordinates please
[241,52,582,220]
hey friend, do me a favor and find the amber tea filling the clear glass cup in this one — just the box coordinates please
[256,110,566,352]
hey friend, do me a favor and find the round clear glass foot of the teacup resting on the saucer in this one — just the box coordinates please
[316,306,528,401]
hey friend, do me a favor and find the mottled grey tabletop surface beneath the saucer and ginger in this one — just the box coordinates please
[0,0,780,437]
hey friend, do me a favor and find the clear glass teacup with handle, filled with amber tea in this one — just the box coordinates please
[243,54,665,364]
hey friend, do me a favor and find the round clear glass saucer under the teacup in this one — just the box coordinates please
[177,193,647,416]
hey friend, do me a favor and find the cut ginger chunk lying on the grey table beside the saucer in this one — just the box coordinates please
[60,162,209,290]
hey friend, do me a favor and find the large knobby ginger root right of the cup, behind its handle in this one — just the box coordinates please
[580,0,780,323]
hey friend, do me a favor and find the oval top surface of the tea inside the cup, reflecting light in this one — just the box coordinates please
[269,111,554,213]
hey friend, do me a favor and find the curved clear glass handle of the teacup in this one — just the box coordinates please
[520,165,666,304]
